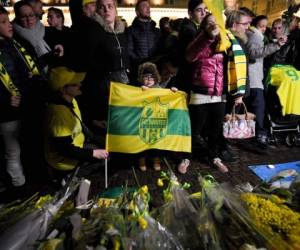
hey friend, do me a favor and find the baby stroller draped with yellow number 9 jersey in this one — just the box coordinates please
[266,65,300,147]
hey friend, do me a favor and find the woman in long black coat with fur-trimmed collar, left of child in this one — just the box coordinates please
[80,0,129,133]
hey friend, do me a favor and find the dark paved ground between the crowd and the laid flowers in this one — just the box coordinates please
[0,141,300,206]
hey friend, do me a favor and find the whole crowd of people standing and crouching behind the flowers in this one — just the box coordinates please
[0,0,300,193]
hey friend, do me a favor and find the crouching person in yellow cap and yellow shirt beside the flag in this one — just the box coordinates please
[45,67,108,178]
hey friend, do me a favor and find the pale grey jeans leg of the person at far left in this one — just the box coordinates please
[0,121,25,187]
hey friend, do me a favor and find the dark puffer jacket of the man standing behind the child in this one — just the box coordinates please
[128,17,160,65]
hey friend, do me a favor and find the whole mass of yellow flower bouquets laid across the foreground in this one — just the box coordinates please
[0,171,300,250]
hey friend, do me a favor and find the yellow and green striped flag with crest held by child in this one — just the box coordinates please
[106,82,191,153]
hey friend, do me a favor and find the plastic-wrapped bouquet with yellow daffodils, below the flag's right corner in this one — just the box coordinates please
[153,171,200,249]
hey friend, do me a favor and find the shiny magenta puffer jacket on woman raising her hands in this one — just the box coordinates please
[186,32,225,96]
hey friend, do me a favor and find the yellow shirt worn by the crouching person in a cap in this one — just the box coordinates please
[45,99,84,170]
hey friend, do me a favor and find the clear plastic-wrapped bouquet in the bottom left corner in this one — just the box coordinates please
[0,178,79,250]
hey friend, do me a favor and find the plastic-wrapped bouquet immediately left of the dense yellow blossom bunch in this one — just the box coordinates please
[198,176,284,250]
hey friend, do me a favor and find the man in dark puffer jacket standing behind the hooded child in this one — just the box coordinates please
[128,0,160,83]
